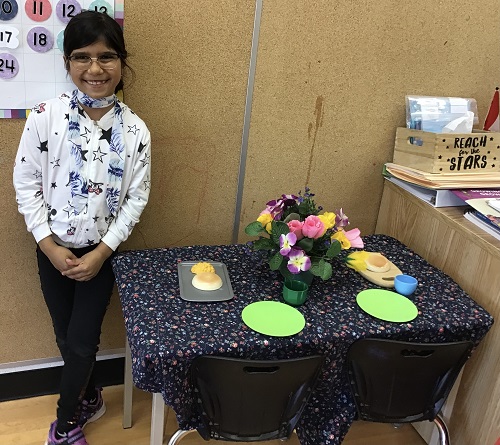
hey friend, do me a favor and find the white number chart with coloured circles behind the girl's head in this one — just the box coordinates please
[0,0,124,118]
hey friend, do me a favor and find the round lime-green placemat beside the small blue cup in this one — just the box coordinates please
[356,289,418,323]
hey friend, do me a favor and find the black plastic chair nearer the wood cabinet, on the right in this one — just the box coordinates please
[348,338,473,445]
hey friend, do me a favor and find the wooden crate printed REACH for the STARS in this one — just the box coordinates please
[393,128,500,173]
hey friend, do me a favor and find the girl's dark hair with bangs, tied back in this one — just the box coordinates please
[63,11,133,91]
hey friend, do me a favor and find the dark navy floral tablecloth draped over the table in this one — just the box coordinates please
[113,235,493,445]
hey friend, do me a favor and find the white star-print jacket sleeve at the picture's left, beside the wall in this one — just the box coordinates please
[13,113,51,242]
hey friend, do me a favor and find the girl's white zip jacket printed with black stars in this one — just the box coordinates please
[14,93,151,250]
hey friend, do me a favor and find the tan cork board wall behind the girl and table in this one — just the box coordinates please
[0,0,500,363]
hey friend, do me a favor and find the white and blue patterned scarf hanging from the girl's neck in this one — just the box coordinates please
[68,89,125,216]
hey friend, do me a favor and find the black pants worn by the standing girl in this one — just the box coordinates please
[37,246,115,425]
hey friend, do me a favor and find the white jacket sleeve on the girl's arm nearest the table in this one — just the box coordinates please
[101,128,151,250]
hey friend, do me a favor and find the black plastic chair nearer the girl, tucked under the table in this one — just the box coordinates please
[168,355,323,445]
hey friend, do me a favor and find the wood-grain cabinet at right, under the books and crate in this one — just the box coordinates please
[375,181,500,445]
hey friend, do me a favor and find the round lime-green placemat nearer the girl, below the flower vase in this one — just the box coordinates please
[241,301,306,337]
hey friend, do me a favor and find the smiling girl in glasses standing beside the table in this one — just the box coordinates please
[14,11,150,445]
